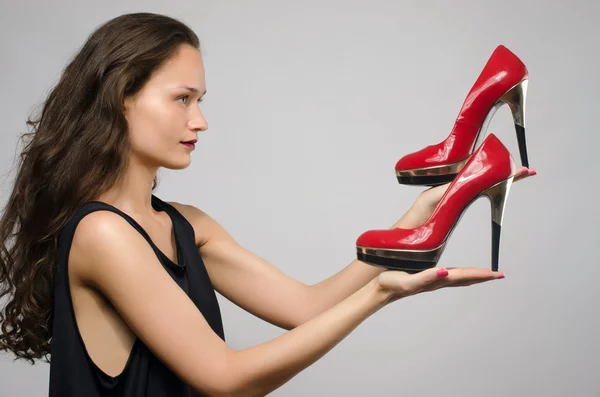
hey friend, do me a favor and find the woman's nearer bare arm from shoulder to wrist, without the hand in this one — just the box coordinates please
[73,211,390,396]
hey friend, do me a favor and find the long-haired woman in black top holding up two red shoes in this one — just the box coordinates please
[0,13,531,397]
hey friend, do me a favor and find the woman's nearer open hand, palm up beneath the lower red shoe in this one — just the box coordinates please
[377,267,504,304]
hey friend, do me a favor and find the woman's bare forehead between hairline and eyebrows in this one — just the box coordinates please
[151,45,205,89]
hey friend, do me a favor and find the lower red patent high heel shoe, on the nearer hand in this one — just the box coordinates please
[356,134,515,273]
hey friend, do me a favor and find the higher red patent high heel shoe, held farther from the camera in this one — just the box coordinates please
[396,45,529,186]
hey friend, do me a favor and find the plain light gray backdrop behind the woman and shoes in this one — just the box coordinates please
[0,0,600,397]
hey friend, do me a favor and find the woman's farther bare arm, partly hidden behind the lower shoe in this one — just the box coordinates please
[170,202,423,330]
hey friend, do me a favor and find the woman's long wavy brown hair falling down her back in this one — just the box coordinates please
[0,13,200,364]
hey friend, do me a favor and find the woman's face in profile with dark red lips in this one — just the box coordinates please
[125,45,208,169]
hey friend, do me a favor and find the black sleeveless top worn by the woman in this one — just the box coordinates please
[49,195,225,397]
